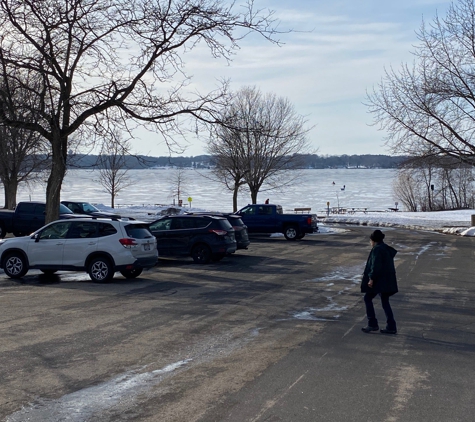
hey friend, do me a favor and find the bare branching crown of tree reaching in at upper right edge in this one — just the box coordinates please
[368,0,475,165]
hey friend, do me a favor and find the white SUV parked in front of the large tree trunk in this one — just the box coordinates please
[0,218,158,282]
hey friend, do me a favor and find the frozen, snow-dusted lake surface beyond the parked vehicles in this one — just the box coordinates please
[9,169,397,212]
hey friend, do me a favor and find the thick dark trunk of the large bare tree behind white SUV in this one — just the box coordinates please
[46,133,68,224]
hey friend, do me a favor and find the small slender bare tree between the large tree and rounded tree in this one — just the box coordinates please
[98,136,133,208]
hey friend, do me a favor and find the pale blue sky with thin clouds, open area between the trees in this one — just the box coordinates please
[133,0,450,156]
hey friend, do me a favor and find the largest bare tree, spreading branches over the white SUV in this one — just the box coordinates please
[0,0,276,221]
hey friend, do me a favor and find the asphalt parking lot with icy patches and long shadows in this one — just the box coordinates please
[0,227,475,422]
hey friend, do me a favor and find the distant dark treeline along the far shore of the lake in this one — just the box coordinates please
[68,154,407,169]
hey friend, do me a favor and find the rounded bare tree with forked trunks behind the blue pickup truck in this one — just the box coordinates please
[208,87,310,211]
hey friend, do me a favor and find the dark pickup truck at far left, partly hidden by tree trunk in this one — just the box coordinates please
[0,201,85,239]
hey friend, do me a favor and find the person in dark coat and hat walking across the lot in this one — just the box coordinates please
[361,230,398,334]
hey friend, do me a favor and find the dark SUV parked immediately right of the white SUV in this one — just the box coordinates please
[149,214,237,264]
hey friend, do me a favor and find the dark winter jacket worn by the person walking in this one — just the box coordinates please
[361,242,398,295]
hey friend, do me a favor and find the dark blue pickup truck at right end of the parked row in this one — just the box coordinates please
[235,204,318,240]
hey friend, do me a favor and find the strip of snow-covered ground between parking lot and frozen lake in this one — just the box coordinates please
[95,204,475,236]
